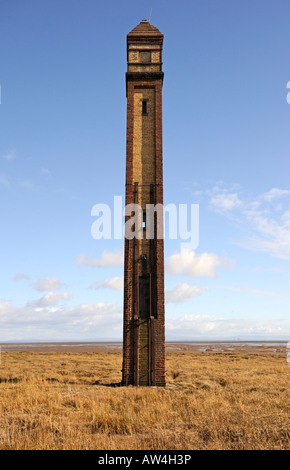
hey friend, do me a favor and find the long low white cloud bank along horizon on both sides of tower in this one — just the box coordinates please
[0,293,290,342]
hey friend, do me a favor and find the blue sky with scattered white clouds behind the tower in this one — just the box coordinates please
[0,0,290,342]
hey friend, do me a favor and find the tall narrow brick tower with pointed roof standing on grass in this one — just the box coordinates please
[122,20,165,386]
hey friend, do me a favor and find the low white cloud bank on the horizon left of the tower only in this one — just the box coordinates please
[0,298,123,341]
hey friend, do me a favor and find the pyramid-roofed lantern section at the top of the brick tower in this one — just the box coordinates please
[127,20,163,80]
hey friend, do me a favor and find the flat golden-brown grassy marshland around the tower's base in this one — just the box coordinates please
[0,345,290,450]
